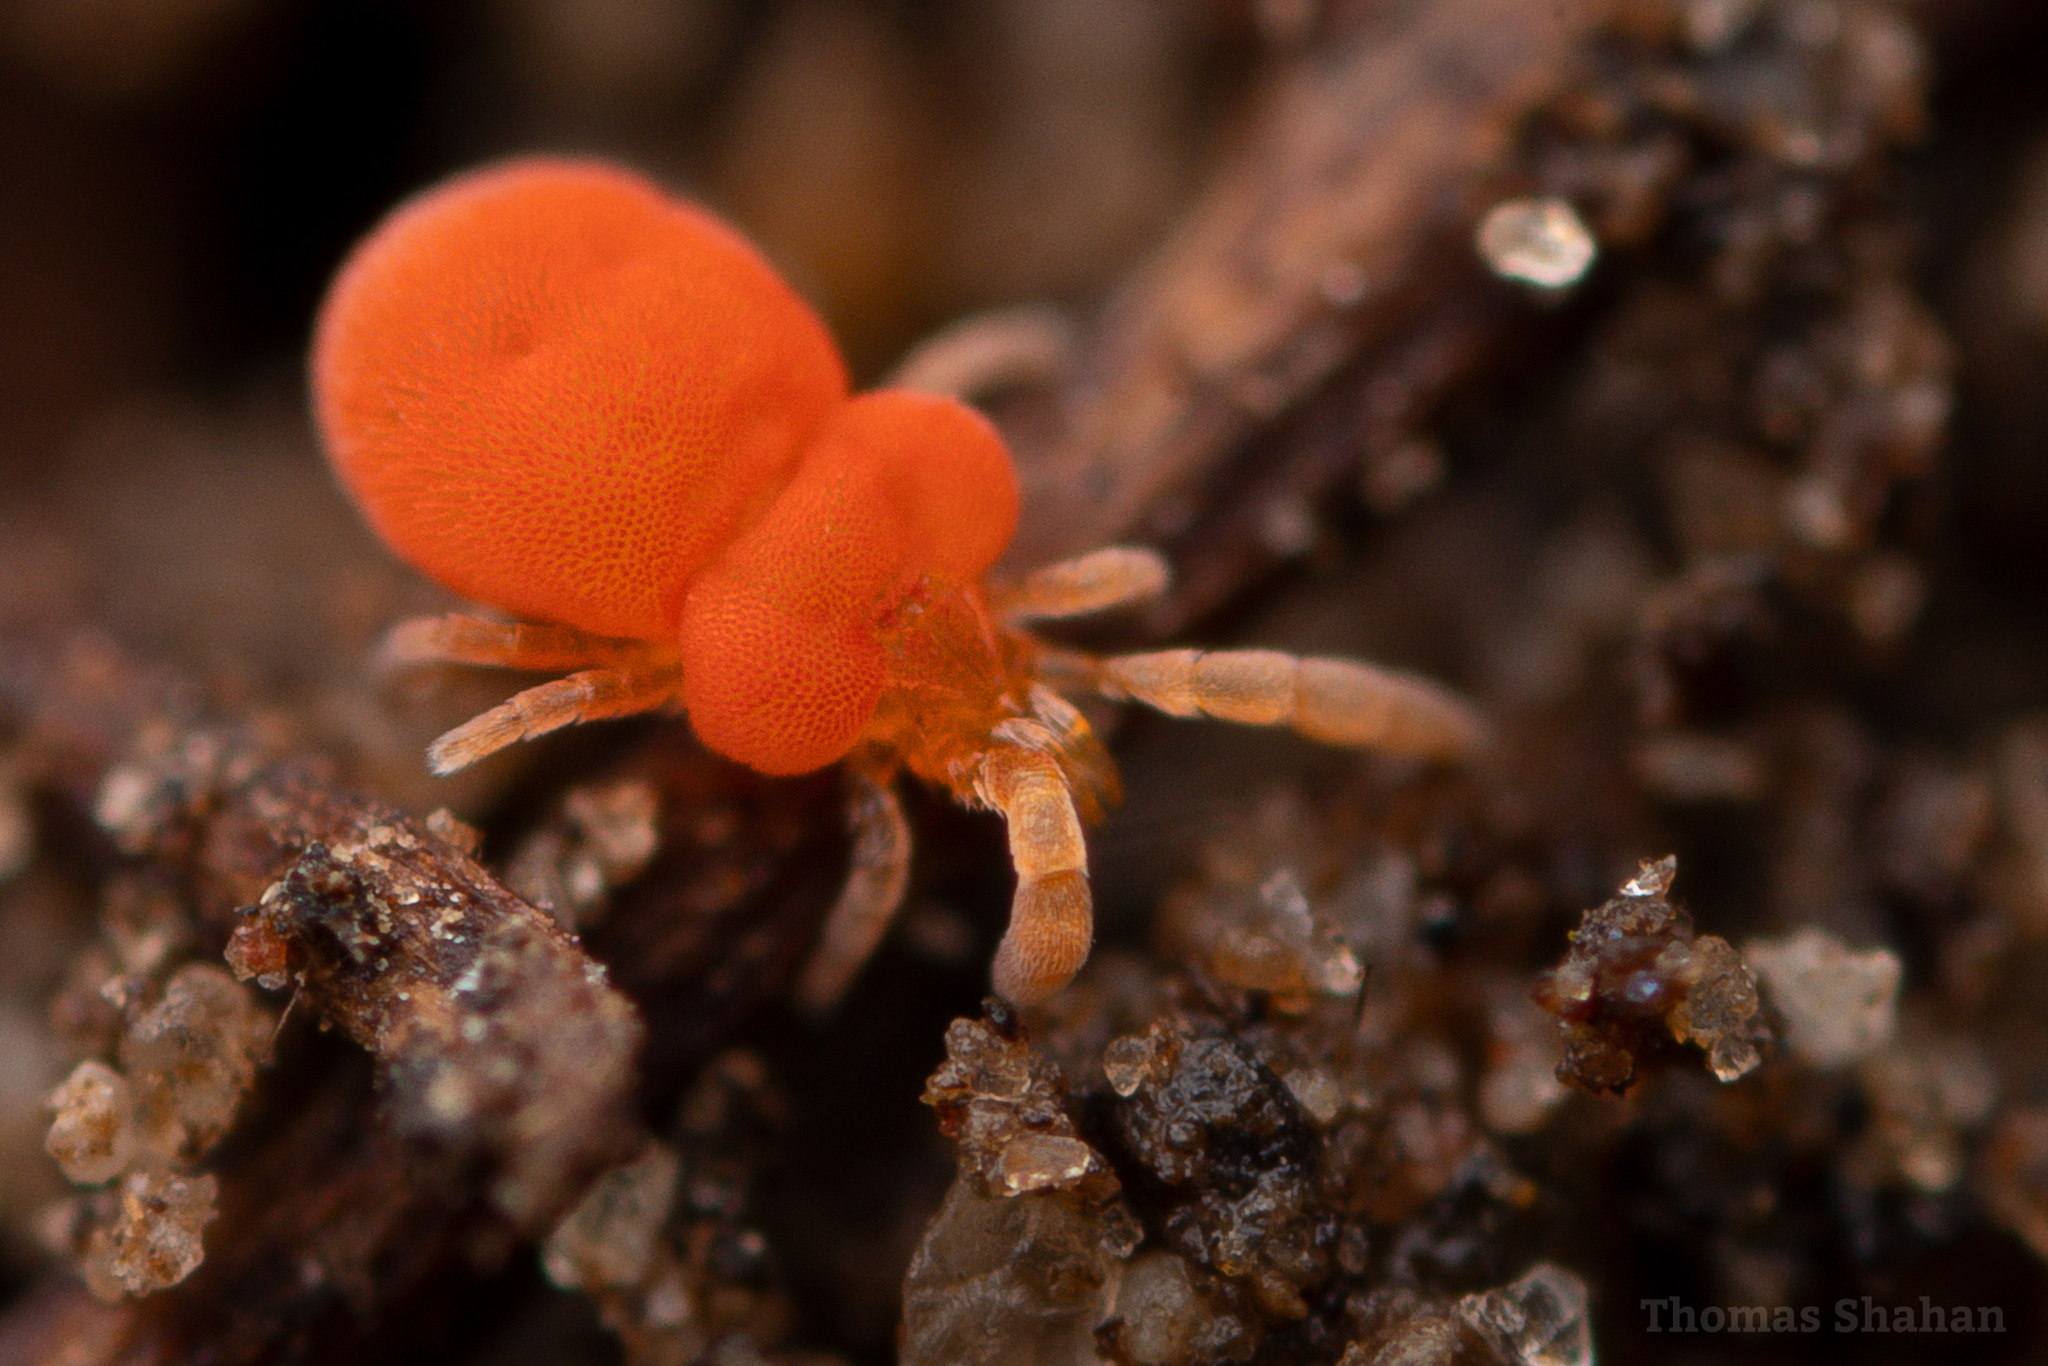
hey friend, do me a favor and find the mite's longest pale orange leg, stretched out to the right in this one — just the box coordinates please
[1096,649,1485,760]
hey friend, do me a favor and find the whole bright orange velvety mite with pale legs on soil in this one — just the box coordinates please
[311,160,1479,1008]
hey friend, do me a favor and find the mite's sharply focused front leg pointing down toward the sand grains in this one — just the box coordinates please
[975,737,1096,1006]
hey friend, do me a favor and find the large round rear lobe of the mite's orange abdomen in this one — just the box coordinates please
[313,160,846,641]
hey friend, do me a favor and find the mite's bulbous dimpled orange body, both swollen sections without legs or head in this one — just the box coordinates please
[313,160,1018,772]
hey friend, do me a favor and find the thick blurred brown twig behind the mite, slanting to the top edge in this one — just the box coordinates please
[1012,0,1614,633]
